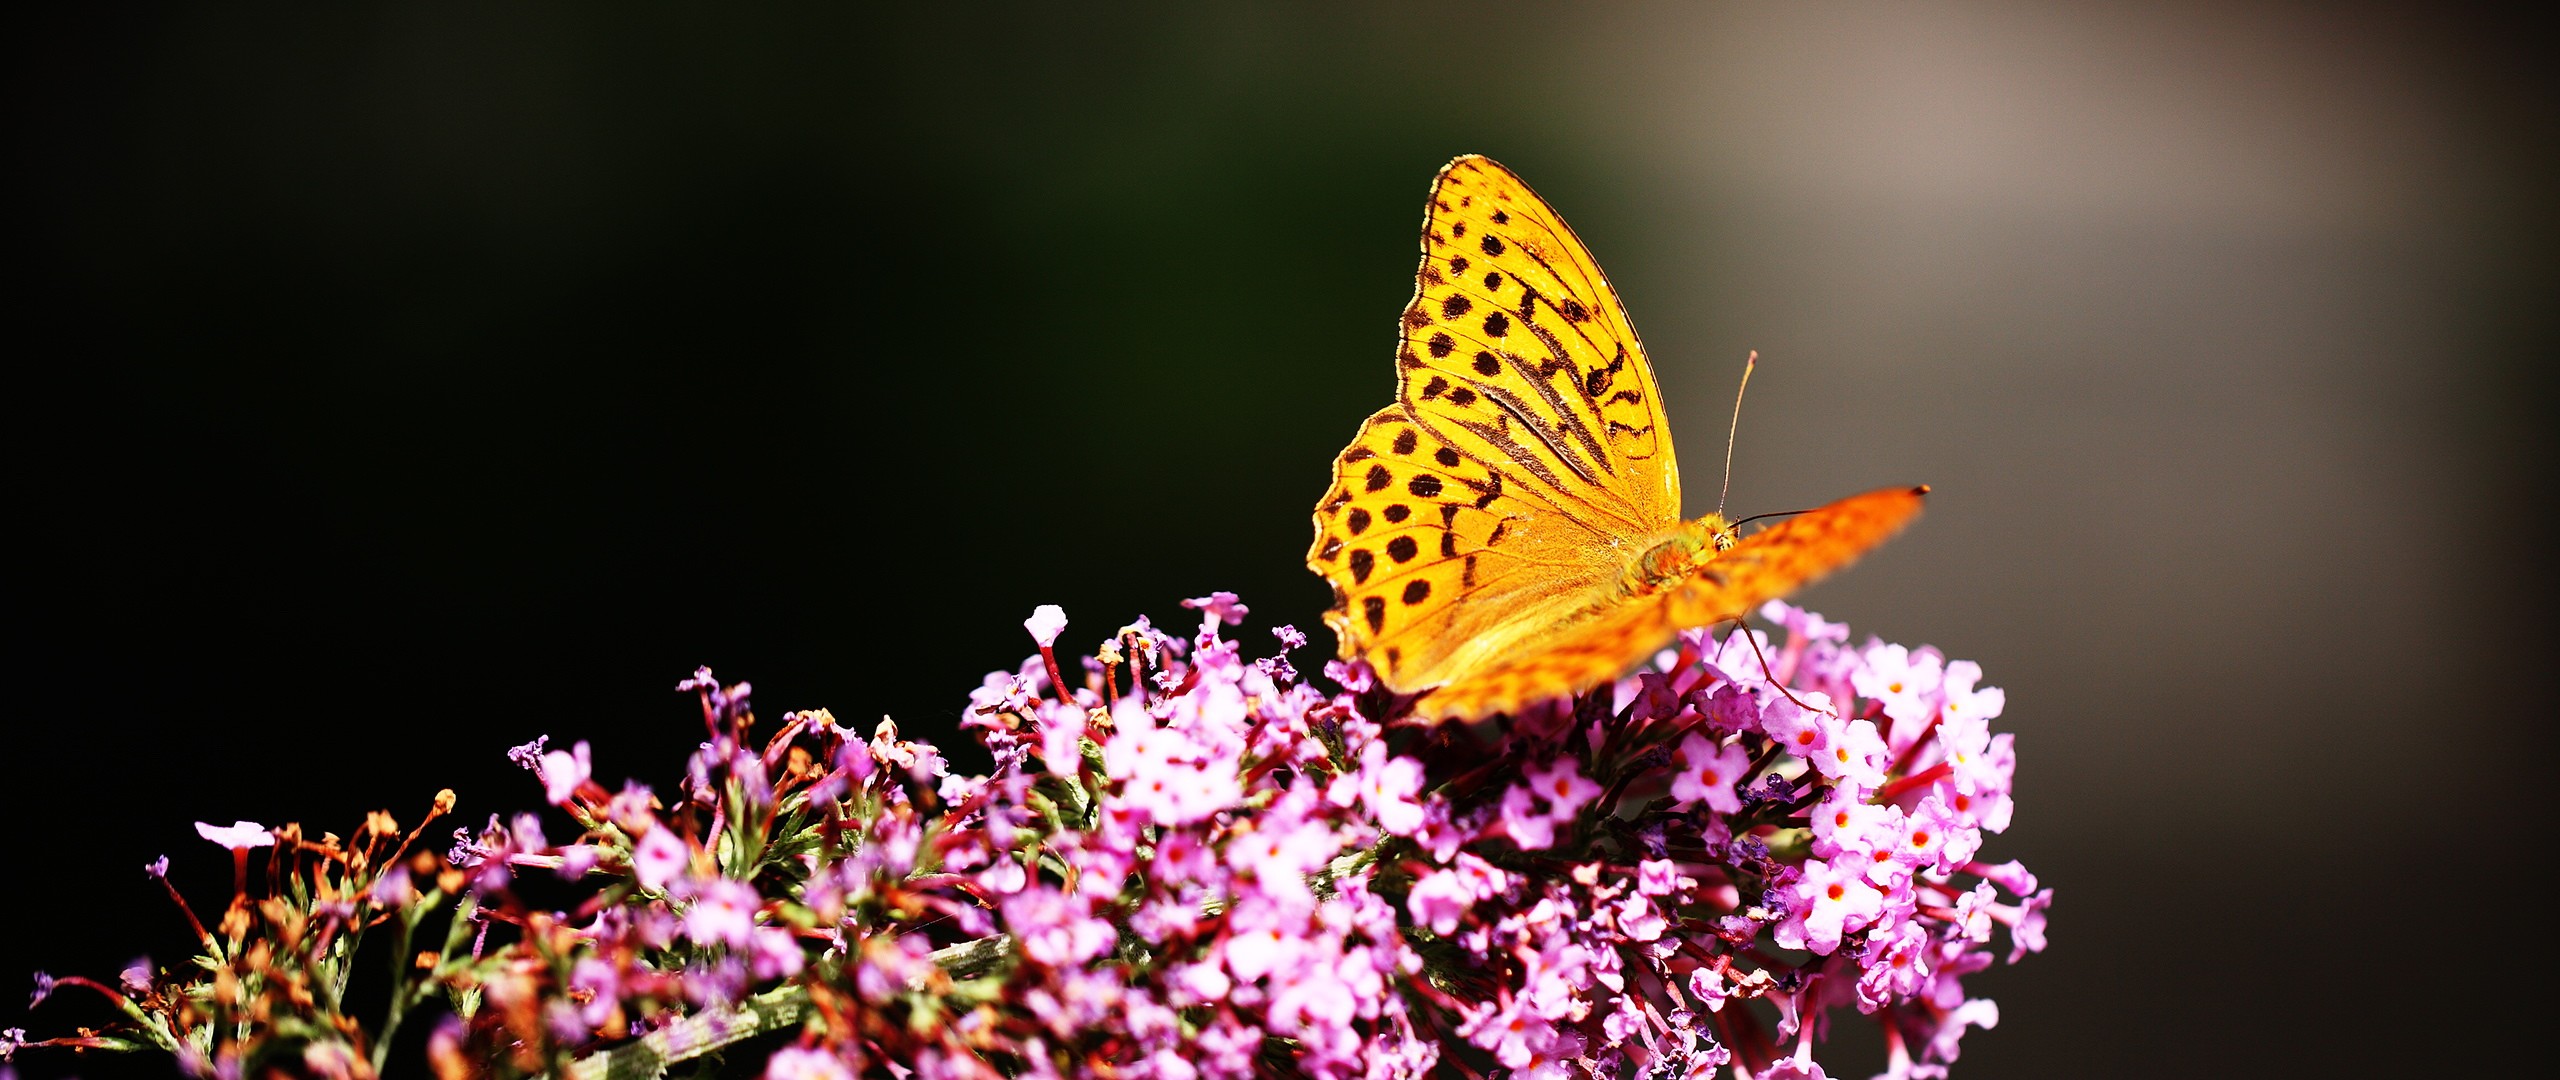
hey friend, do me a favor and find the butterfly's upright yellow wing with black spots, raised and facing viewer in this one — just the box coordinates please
[1308,156,1679,691]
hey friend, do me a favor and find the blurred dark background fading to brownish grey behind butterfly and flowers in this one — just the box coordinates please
[0,5,2560,1080]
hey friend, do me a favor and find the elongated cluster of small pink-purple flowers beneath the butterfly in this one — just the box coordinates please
[0,594,2053,1080]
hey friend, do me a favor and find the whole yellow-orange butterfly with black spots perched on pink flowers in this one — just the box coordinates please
[1306,156,1928,719]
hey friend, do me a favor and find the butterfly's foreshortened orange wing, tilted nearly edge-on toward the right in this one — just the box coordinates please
[1416,486,1928,717]
